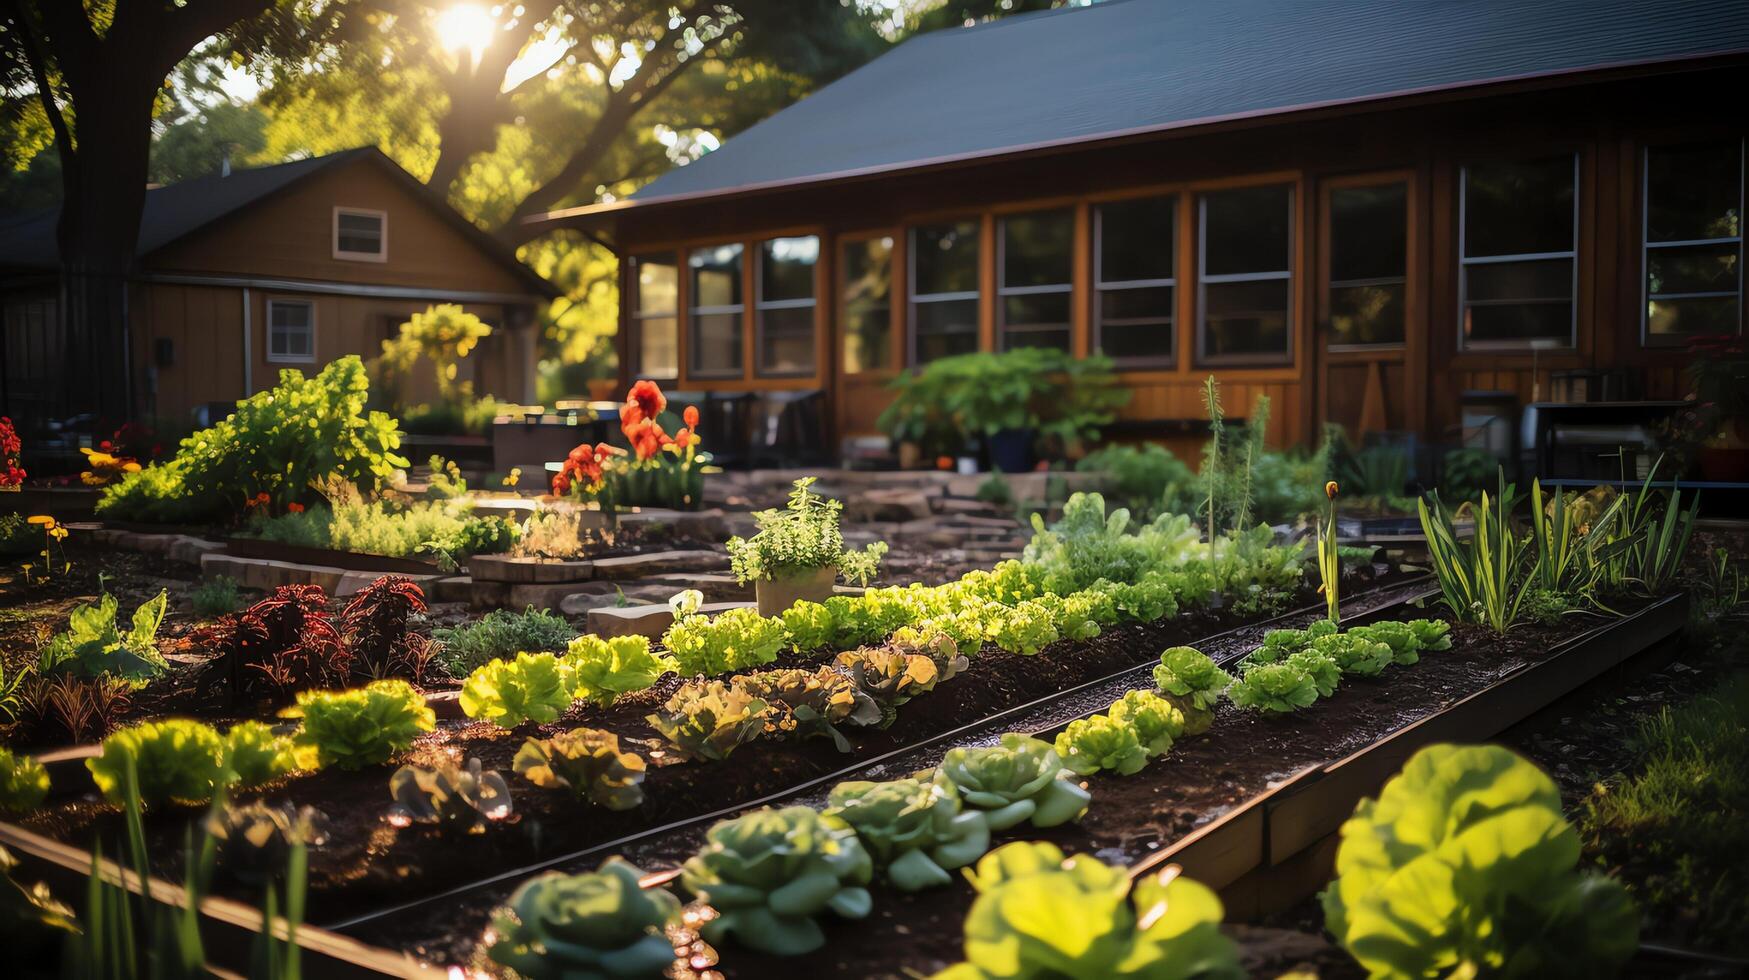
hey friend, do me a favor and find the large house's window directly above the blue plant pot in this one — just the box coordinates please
[995,210,1076,350]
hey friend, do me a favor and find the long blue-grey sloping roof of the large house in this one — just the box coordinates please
[615,0,1749,201]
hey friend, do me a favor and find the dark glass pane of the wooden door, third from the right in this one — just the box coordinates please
[1329,182,1410,348]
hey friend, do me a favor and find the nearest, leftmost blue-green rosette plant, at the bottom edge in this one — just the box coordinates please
[486,858,680,980]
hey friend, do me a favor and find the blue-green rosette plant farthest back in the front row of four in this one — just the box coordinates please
[936,732,1093,830]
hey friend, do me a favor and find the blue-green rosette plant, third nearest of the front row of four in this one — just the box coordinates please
[826,777,990,891]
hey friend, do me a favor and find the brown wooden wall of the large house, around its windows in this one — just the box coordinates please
[614,63,1749,455]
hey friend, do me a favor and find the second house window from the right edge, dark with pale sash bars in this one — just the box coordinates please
[1459,154,1579,348]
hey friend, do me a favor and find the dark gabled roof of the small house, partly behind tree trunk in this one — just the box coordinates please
[0,147,558,296]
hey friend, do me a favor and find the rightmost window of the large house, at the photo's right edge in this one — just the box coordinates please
[1644,140,1744,347]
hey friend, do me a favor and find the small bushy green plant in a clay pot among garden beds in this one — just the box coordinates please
[729,476,887,616]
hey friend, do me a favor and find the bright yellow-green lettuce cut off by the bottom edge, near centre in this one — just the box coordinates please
[936,842,1245,980]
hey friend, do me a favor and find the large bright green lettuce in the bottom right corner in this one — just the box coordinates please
[1324,746,1639,978]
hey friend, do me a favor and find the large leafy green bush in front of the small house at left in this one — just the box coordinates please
[98,355,408,523]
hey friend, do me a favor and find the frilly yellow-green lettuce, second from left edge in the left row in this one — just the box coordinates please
[86,718,229,805]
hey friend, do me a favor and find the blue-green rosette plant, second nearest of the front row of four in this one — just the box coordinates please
[680,807,875,956]
